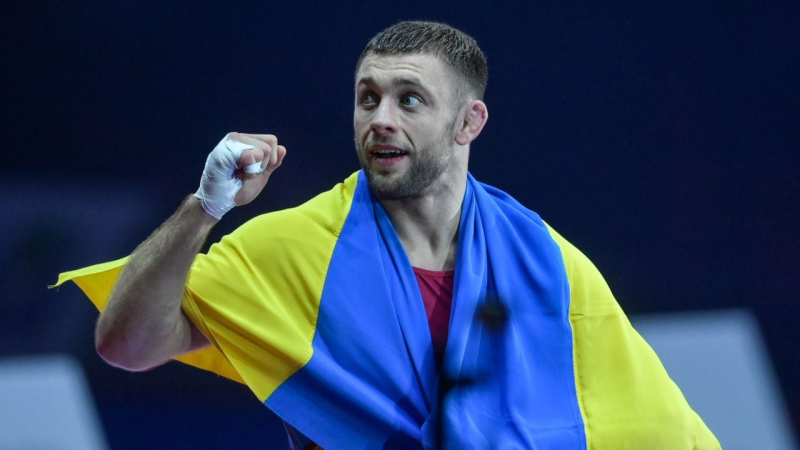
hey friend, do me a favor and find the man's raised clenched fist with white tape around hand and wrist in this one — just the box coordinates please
[194,133,286,219]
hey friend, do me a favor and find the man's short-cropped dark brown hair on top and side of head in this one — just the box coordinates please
[356,21,489,100]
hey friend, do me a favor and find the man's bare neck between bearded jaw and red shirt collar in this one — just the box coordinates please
[380,171,467,270]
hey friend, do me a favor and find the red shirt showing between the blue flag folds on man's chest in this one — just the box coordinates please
[414,267,455,362]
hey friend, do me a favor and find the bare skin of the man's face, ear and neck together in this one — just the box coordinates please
[353,54,488,270]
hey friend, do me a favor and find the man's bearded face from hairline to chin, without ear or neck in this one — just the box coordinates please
[353,54,459,200]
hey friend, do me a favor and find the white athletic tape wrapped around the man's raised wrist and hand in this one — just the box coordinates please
[194,134,261,219]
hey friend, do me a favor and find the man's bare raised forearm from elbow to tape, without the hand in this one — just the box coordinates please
[95,196,217,370]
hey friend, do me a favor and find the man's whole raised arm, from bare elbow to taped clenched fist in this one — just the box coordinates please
[95,133,286,371]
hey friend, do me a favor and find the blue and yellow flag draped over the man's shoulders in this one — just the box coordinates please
[58,172,719,450]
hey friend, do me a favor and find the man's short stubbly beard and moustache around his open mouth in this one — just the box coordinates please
[355,121,457,200]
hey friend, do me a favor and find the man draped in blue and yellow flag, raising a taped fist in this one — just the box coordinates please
[59,22,719,449]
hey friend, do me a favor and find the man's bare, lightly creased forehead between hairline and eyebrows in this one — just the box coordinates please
[356,53,453,88]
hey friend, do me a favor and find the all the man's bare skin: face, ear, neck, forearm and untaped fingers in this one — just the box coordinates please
[95,54,488,371]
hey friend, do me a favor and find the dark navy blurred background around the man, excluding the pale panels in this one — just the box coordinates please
[0,0,800,449]
